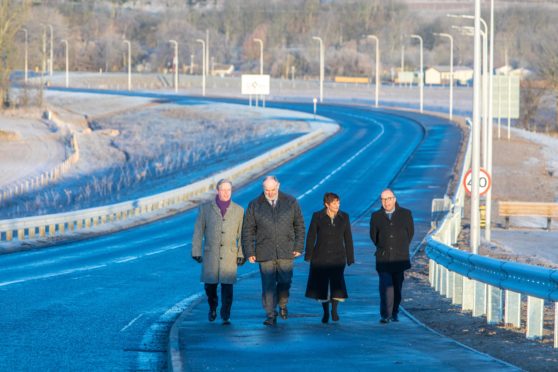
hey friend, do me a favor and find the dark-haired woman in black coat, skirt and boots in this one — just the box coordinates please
[304,192,355,323]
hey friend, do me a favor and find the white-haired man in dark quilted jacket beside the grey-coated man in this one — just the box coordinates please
[242,176,305,326]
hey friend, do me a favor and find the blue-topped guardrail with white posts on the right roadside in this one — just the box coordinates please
[426,119,558,348]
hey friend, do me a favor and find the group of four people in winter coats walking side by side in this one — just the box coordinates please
[192,176,414,326]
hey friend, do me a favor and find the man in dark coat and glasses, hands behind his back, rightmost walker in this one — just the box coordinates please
[370,189,414,324]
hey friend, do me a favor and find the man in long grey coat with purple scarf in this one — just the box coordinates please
[192,179,245,324]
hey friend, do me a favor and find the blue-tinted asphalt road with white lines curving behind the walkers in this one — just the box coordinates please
[0,96,461,370]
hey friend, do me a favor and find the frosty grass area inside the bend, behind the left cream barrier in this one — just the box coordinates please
[0,104,310,218]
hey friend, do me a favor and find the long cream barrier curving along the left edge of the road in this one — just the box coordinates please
[0,123,339,246]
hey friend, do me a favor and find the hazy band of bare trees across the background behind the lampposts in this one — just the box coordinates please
[0,0,558,132]
